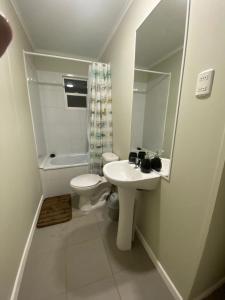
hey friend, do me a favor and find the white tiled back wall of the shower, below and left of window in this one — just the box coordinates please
[38,71,88,154]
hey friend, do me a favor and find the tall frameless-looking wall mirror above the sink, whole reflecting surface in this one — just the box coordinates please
[131,0,189,178]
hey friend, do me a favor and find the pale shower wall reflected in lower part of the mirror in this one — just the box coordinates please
[131,72,169,151]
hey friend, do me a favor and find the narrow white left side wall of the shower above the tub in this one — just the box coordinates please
[25,55,47,160]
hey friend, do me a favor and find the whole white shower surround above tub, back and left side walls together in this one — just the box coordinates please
[26,55,88,163]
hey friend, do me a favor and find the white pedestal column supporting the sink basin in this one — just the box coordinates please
[117,186,136,251]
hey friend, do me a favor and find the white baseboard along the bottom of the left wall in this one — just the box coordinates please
[10,195,44,300]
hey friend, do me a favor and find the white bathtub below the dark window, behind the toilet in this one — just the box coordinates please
[39,153,88,197]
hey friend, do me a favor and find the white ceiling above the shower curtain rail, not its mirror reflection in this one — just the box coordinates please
[11,0,133,58]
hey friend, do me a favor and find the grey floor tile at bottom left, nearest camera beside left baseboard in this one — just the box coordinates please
[18,245,66,300]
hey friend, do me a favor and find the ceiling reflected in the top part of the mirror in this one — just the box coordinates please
[135,0,187,68]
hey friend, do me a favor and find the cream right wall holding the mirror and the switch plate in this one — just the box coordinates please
[103,0,225,299]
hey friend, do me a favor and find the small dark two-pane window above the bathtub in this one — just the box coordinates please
[64,78,87,109]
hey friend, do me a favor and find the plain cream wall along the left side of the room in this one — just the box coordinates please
[0,0,42,300]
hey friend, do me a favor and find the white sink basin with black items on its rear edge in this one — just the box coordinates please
[103,160,160,190]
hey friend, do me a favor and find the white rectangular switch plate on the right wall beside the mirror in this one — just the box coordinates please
[195,69,215,98]
